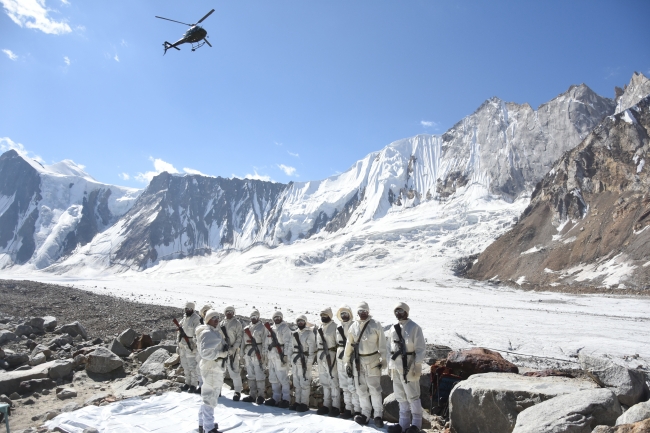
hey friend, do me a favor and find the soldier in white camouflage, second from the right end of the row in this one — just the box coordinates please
[343,302,386,419]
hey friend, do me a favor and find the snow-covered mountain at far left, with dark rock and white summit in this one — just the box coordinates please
[0,150,140,269]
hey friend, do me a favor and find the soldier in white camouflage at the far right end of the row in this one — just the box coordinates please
[388,302,426,430]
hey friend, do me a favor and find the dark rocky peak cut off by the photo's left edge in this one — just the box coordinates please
[0,150,42,264]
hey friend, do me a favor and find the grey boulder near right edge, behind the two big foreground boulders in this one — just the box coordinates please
[578,353,648,406]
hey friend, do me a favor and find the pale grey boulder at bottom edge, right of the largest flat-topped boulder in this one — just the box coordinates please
[512,388,623,433]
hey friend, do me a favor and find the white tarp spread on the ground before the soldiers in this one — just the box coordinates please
[46,388,377,433]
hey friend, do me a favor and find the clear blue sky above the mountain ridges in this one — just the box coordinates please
[0,0,650,188]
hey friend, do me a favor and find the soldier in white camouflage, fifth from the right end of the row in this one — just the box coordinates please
[291,316,316,406]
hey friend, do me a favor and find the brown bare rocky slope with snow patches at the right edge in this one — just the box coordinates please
[468,97,650,289]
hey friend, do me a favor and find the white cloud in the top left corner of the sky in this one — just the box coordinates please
[0,0,72,35]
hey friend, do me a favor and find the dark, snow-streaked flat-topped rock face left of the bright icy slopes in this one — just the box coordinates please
[113,172,286,267]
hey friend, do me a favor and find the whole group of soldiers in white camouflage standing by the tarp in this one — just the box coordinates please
[179,302,425,433]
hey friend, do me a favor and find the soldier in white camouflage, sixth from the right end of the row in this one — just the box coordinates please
[266,311,293,403]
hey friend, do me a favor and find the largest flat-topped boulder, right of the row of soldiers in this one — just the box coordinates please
[449,373,596,433]
